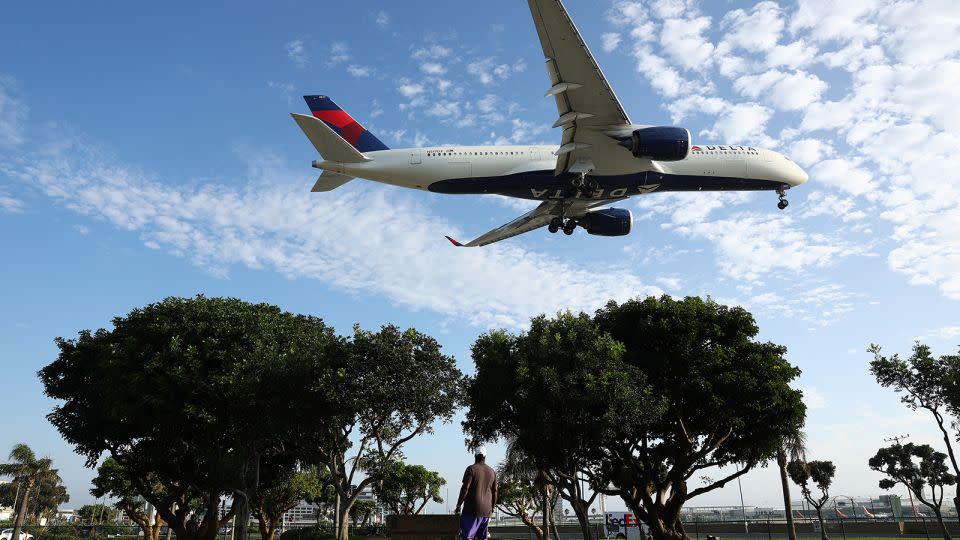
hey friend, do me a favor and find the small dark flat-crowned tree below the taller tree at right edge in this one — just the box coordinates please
[869,443,957,540]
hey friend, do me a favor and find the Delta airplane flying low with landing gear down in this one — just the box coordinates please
[291,0,808,247]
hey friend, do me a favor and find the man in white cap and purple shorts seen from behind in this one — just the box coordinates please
[456,446,497,540]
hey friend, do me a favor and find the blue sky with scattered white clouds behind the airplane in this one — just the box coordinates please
[0,0,960,516]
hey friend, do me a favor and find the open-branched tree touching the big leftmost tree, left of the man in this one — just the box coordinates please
[315,325,463,540]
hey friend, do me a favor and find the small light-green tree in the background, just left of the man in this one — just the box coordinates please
[374,461,447,515]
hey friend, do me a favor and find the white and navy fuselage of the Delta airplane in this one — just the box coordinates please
[314,145,807,199]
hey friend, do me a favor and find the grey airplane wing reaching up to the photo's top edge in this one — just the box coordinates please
[527,0,631,175]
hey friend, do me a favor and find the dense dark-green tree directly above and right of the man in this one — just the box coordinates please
[464,312,659,540]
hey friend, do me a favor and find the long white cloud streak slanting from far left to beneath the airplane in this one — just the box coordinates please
[11,138,662,327]
